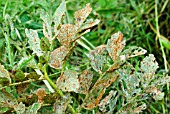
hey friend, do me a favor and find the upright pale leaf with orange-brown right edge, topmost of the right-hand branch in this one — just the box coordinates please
[106,32,125,61]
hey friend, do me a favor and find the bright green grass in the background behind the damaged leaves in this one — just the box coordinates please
[0,0,170,113]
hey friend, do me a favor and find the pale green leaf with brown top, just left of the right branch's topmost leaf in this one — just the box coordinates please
[89,45,106,74]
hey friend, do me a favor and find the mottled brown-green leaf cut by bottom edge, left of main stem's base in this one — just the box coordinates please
[54,94,72,114]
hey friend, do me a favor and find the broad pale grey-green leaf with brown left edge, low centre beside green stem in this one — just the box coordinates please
[56,70,80,92]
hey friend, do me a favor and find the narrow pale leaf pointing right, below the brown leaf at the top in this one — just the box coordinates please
[80,19,100,31]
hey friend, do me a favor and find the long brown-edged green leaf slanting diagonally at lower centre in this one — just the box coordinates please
[83,71,119,110]
